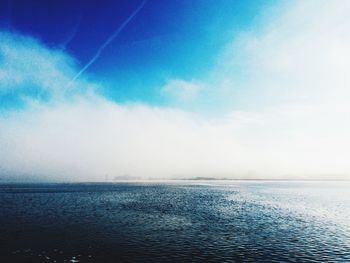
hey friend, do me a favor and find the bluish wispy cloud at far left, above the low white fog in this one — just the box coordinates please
[0,32,94,99]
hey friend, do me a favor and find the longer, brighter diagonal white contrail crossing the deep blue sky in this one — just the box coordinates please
[68,0,147,86]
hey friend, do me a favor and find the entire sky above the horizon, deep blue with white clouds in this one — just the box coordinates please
[0,0,350,181]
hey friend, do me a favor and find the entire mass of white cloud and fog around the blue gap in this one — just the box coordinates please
[0,1,350,181]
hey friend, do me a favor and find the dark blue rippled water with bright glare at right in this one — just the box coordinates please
[0,181,350,262]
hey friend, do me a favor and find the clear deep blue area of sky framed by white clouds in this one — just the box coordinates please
[0,0,272,105]
